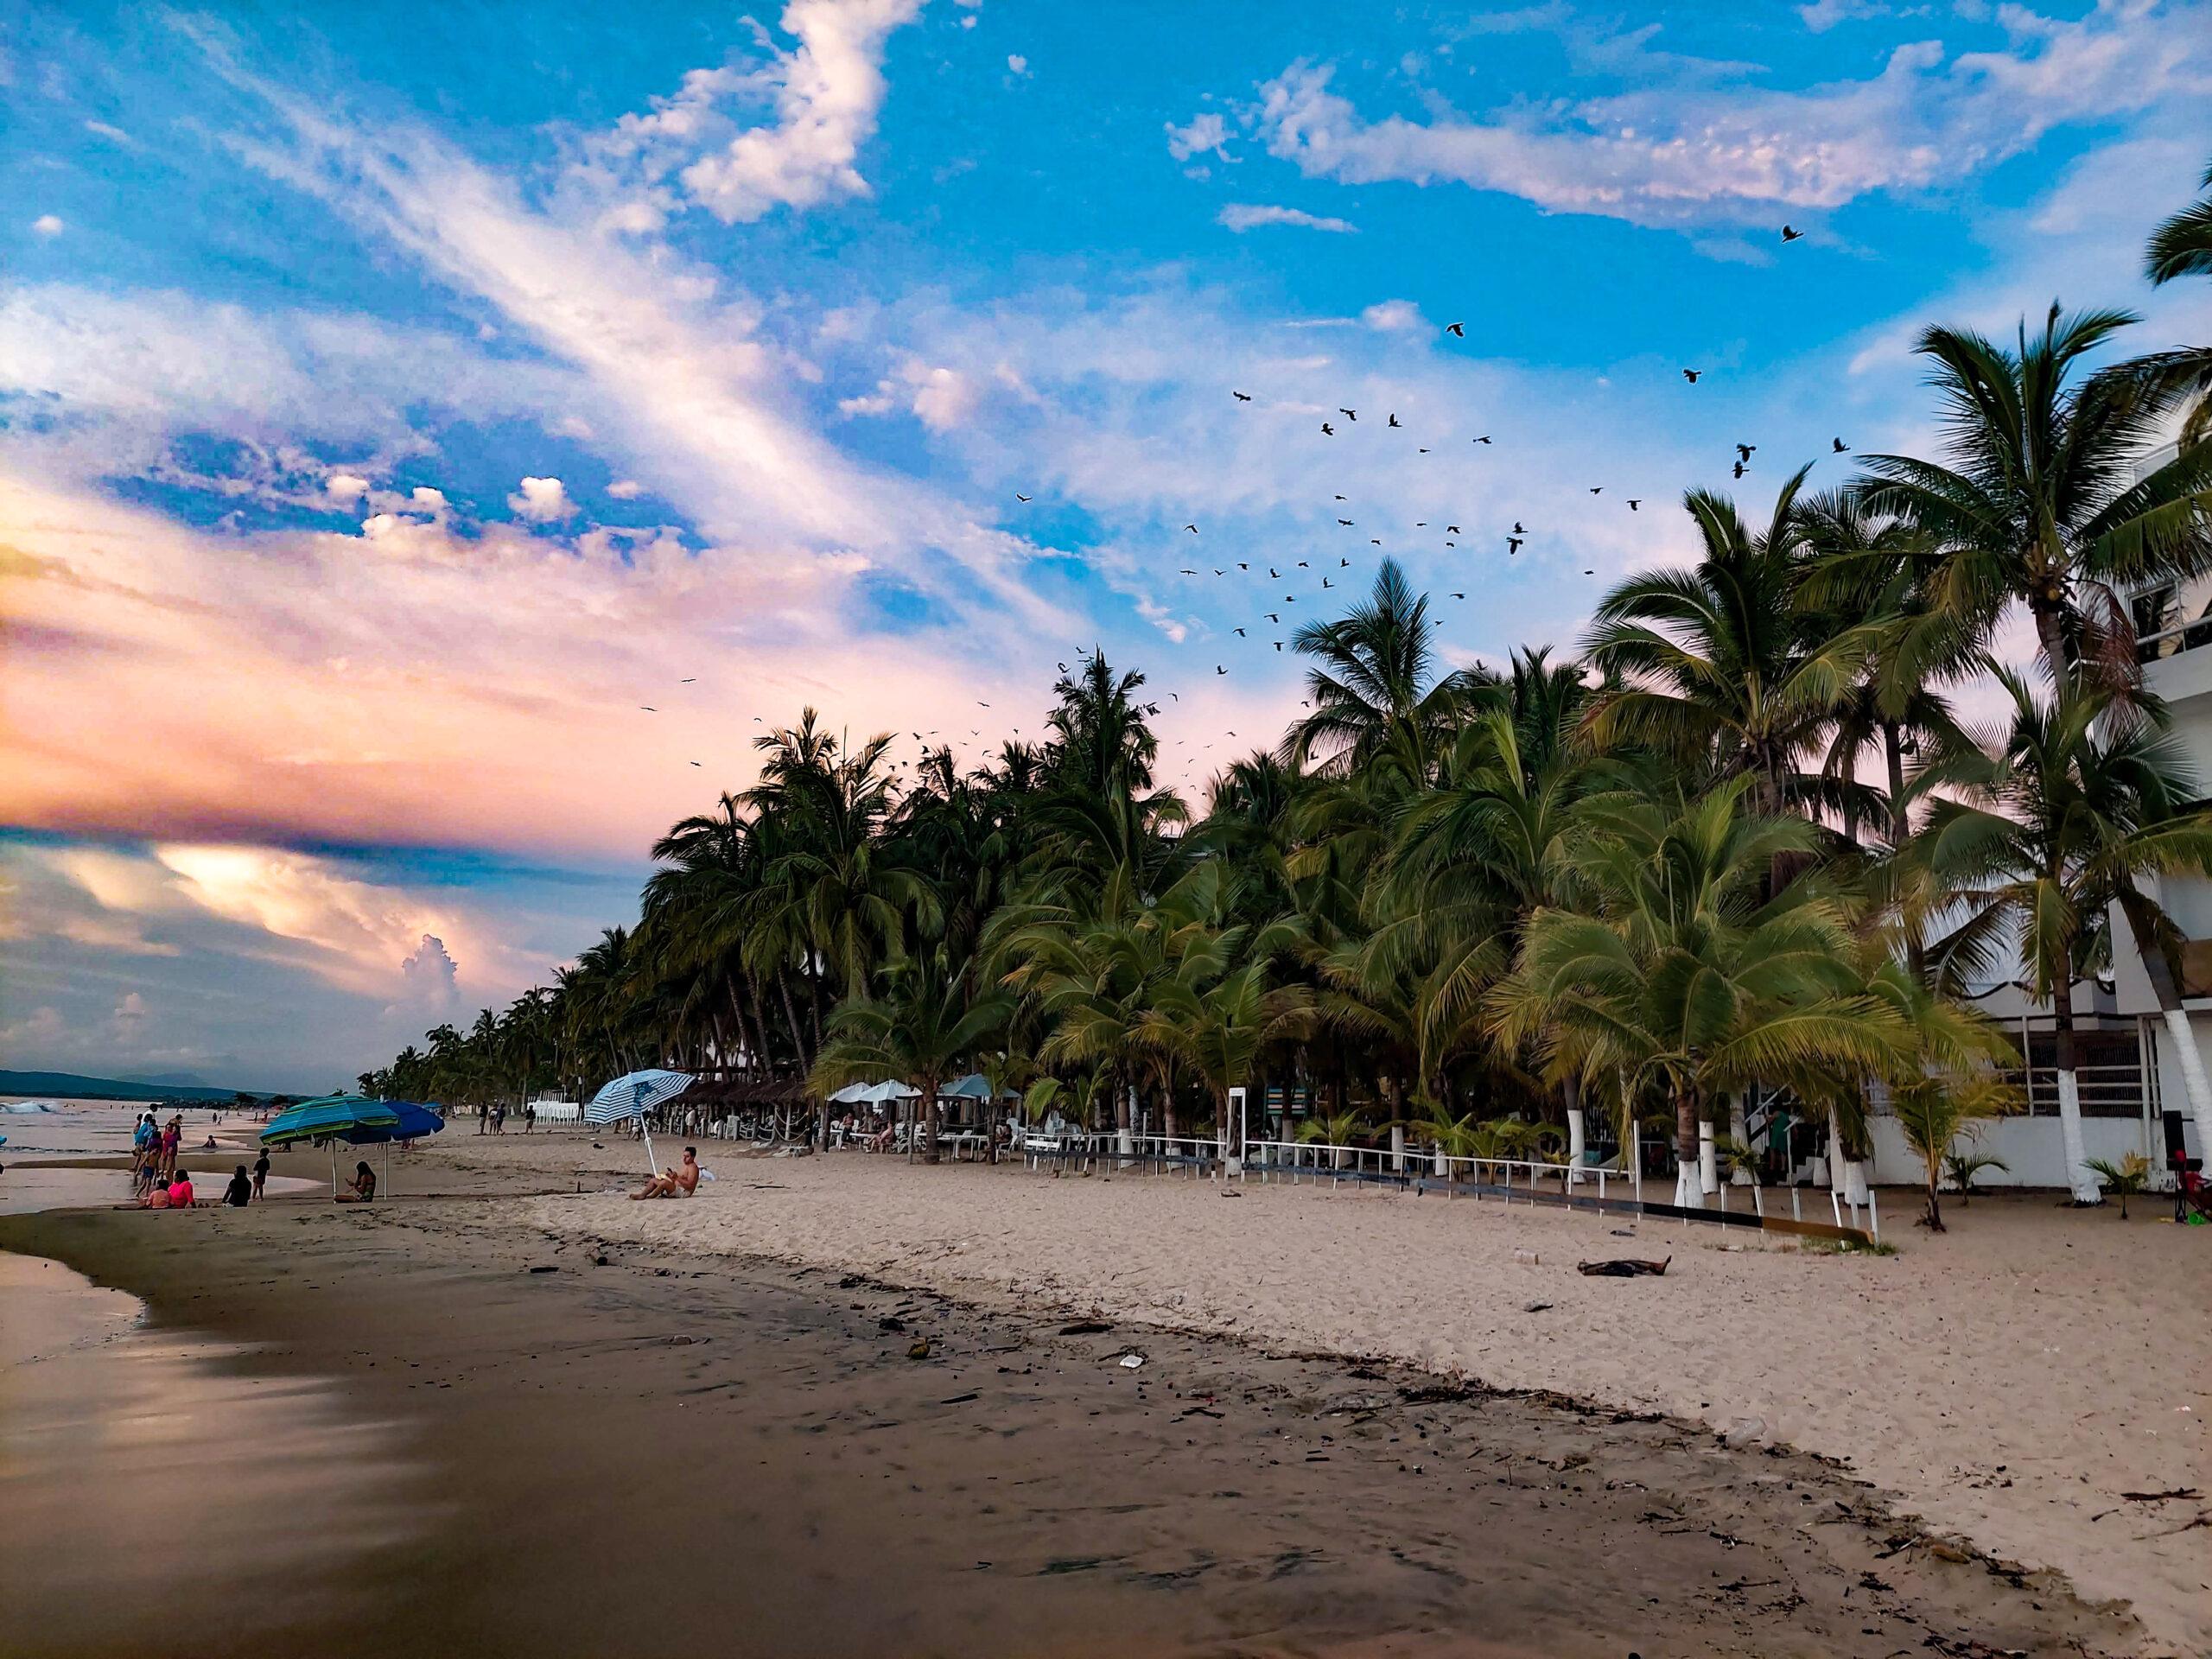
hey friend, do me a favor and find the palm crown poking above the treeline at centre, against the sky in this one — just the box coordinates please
[1283,560,1489,777]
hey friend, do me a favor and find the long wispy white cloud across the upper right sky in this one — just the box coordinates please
[1256,0,2212,226]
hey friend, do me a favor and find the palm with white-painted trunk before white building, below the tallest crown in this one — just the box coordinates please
[1916,671,2212,1204]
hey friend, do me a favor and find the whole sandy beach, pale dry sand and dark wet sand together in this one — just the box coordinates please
[0,1123,2208,1655]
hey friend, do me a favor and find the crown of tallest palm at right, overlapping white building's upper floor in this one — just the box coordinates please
[1863,305,2212,688]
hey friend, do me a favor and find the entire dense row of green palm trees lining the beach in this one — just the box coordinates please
[363,175,2212,1224]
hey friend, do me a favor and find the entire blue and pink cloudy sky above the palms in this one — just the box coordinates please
[0,0,2212,1086]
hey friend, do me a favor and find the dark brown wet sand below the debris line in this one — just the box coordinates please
[0,1197,2137,1659]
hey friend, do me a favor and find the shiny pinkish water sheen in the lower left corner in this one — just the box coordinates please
[0,1252,423,1656]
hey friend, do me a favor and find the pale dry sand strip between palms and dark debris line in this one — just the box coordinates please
[440,1137,2212,1652]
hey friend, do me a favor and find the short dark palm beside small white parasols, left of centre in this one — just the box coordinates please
[810,951,1013,1164]
